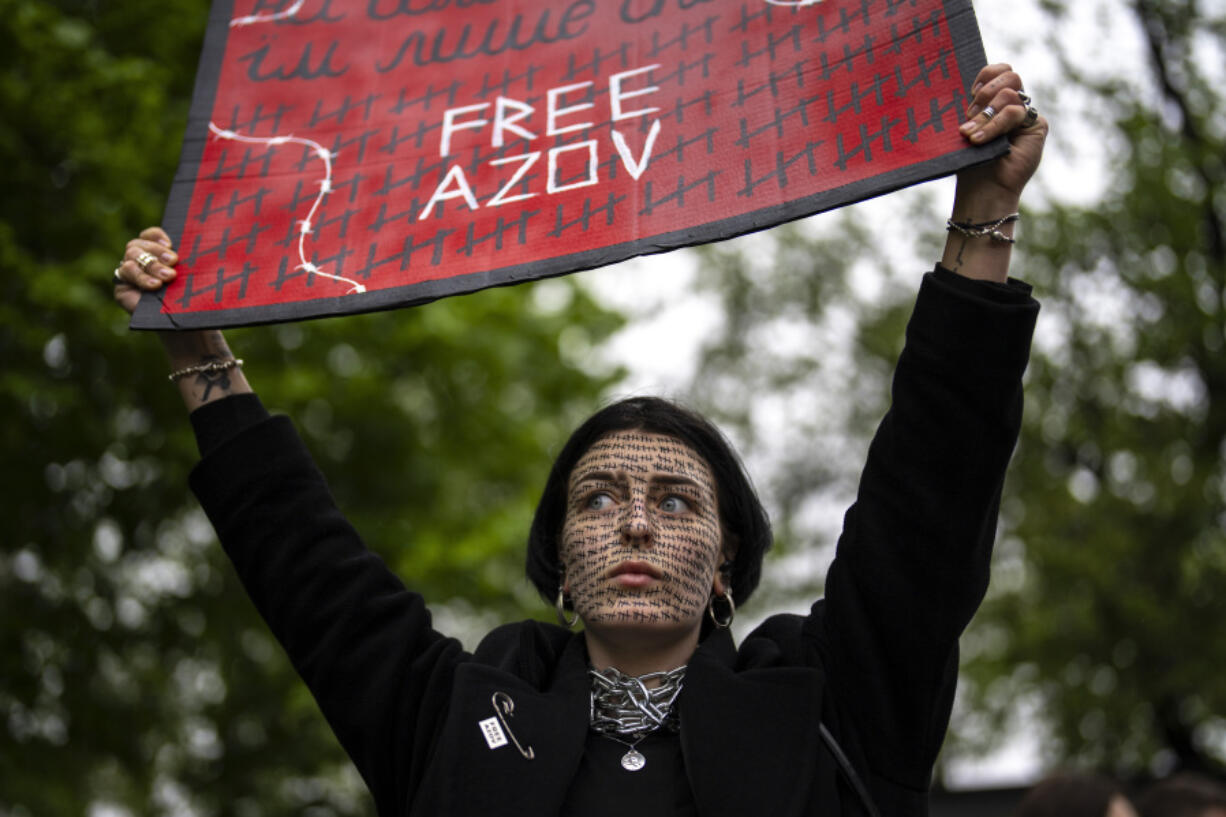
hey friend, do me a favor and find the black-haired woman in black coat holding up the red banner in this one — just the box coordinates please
[115,65,1047,816]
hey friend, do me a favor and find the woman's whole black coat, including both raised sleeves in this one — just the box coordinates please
[191,263,1037,817]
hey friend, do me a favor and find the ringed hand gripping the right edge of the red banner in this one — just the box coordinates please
[958,63,1048,200]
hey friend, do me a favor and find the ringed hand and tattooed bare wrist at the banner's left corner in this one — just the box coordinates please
[115,227,251,412]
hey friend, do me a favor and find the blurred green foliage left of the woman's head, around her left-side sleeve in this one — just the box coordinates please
[0,0,620,817]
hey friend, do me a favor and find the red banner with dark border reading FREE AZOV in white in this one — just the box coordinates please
[132,0,1007,329]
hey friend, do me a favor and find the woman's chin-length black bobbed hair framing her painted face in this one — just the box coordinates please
[527,397,771,605]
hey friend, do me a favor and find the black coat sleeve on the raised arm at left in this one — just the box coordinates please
[191,409,467,815]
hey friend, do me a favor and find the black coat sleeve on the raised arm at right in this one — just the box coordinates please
[805,267,1038,813]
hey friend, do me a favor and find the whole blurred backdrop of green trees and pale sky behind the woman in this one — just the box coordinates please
[0,0,1226,817]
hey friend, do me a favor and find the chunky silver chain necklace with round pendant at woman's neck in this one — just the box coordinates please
[587,666,685,772]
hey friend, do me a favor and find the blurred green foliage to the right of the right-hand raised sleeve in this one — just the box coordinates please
[969,1,1226,774]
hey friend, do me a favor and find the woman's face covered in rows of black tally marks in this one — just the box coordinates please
[560,431,721,627]
